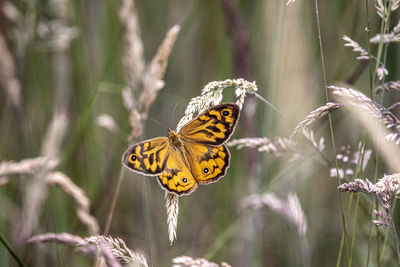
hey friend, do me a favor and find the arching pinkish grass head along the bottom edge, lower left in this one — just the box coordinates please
[28,233,148,267]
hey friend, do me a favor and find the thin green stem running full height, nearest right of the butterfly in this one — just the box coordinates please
[314,0,348,266]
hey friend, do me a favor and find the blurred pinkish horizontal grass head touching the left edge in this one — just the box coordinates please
[0,157,60,176]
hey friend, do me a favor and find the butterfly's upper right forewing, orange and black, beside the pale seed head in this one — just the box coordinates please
[179,103,240,146]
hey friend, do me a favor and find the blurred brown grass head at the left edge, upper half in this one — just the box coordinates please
[0,32,22,110]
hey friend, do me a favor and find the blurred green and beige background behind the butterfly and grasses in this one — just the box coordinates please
[0,0,400,266]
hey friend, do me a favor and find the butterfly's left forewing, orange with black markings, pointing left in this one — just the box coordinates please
[122,137,170,175]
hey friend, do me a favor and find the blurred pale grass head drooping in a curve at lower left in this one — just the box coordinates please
[46,172,99,235]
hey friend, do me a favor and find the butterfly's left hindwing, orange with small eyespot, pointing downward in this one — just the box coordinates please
[158,148,197,195]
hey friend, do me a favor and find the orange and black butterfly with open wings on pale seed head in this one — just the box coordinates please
[122,103,240,195]
